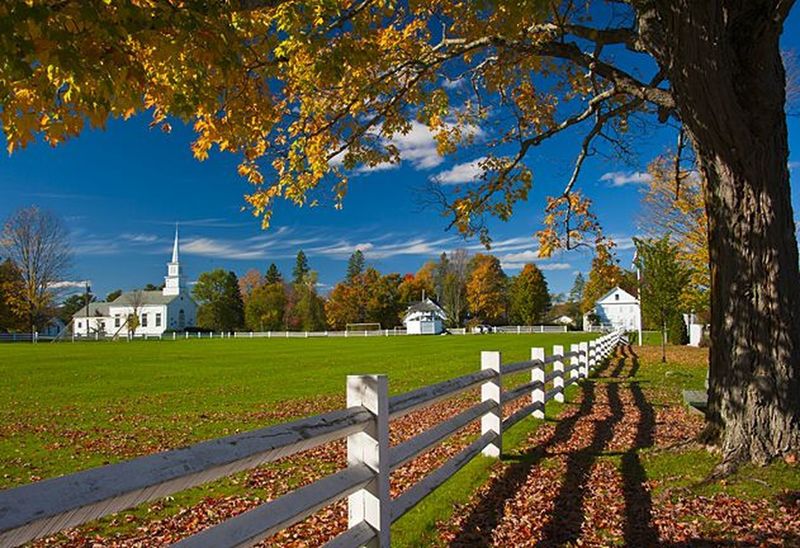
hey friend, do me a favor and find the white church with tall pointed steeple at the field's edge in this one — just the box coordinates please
[72,228,197,337]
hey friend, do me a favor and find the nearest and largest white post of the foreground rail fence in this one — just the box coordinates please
[347,375,391,548]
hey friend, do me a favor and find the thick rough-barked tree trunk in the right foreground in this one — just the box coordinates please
[640,0,800,469]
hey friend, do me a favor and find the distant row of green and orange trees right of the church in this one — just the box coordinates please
[192,250,551,331]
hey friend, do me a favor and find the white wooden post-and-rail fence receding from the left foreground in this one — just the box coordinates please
[0,332,623,547]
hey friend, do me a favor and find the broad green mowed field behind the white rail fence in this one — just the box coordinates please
[0,333,594,488]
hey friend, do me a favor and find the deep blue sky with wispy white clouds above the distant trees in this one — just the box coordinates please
[0,8,800,295]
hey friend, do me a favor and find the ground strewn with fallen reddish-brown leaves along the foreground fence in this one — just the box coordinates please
[7,340,800,547]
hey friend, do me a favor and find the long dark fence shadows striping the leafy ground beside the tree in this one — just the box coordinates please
[444,346,658,547]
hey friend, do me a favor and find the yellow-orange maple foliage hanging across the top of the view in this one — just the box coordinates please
[0,0,655,253]
